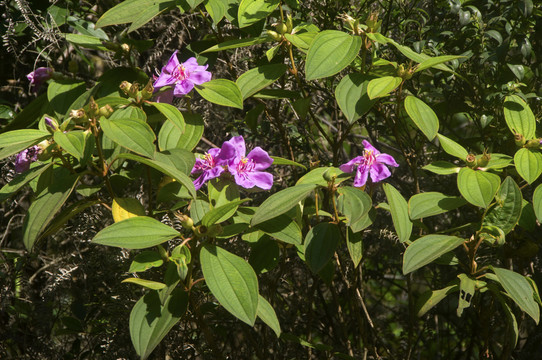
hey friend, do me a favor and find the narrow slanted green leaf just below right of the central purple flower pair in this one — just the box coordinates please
[250,184,316,226]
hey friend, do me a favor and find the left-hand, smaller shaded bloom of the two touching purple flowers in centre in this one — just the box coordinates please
[191,142,235,190]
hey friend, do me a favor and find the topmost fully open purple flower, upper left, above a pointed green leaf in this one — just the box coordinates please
[154,50,211,97]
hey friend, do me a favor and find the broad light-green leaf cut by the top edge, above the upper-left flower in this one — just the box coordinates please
[96,0,176,31]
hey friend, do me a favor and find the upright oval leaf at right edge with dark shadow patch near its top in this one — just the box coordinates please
[504,95,536,140]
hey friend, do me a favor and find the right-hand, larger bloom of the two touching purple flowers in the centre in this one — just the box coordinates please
[228,136,273,190]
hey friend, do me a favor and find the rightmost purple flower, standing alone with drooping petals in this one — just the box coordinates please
[339,140,399,187]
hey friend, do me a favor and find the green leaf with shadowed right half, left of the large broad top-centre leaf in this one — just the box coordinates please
[236,64,288,99]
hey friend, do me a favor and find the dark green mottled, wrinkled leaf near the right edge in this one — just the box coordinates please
[484,176,523,234]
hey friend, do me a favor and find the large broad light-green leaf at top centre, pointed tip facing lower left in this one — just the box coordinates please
[308,30,361,80]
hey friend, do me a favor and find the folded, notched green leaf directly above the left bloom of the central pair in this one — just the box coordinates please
[158,114,204,151]
